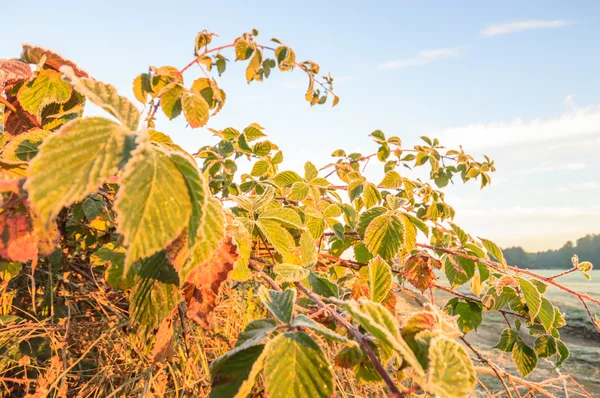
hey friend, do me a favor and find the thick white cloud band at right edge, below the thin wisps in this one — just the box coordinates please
[432,105,600,150]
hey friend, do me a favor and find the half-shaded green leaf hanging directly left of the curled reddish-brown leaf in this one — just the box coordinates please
[129,251,181,334]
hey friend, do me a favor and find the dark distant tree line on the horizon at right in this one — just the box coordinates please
[502,235,600,269]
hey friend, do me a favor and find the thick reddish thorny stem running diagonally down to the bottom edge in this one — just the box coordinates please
[250,260,406,397]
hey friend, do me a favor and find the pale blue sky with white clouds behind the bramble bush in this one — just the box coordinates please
[0,0,600,250]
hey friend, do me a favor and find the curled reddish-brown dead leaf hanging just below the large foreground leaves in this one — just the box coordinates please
[184,236,239,329]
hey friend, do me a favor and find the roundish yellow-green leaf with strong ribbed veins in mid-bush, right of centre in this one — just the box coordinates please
[364,214,404,260]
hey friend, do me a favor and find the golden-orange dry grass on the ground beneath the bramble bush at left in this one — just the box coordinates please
[0,270,385,397]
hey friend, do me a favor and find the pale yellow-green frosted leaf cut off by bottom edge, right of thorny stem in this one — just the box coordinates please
[426,335,477,398]
